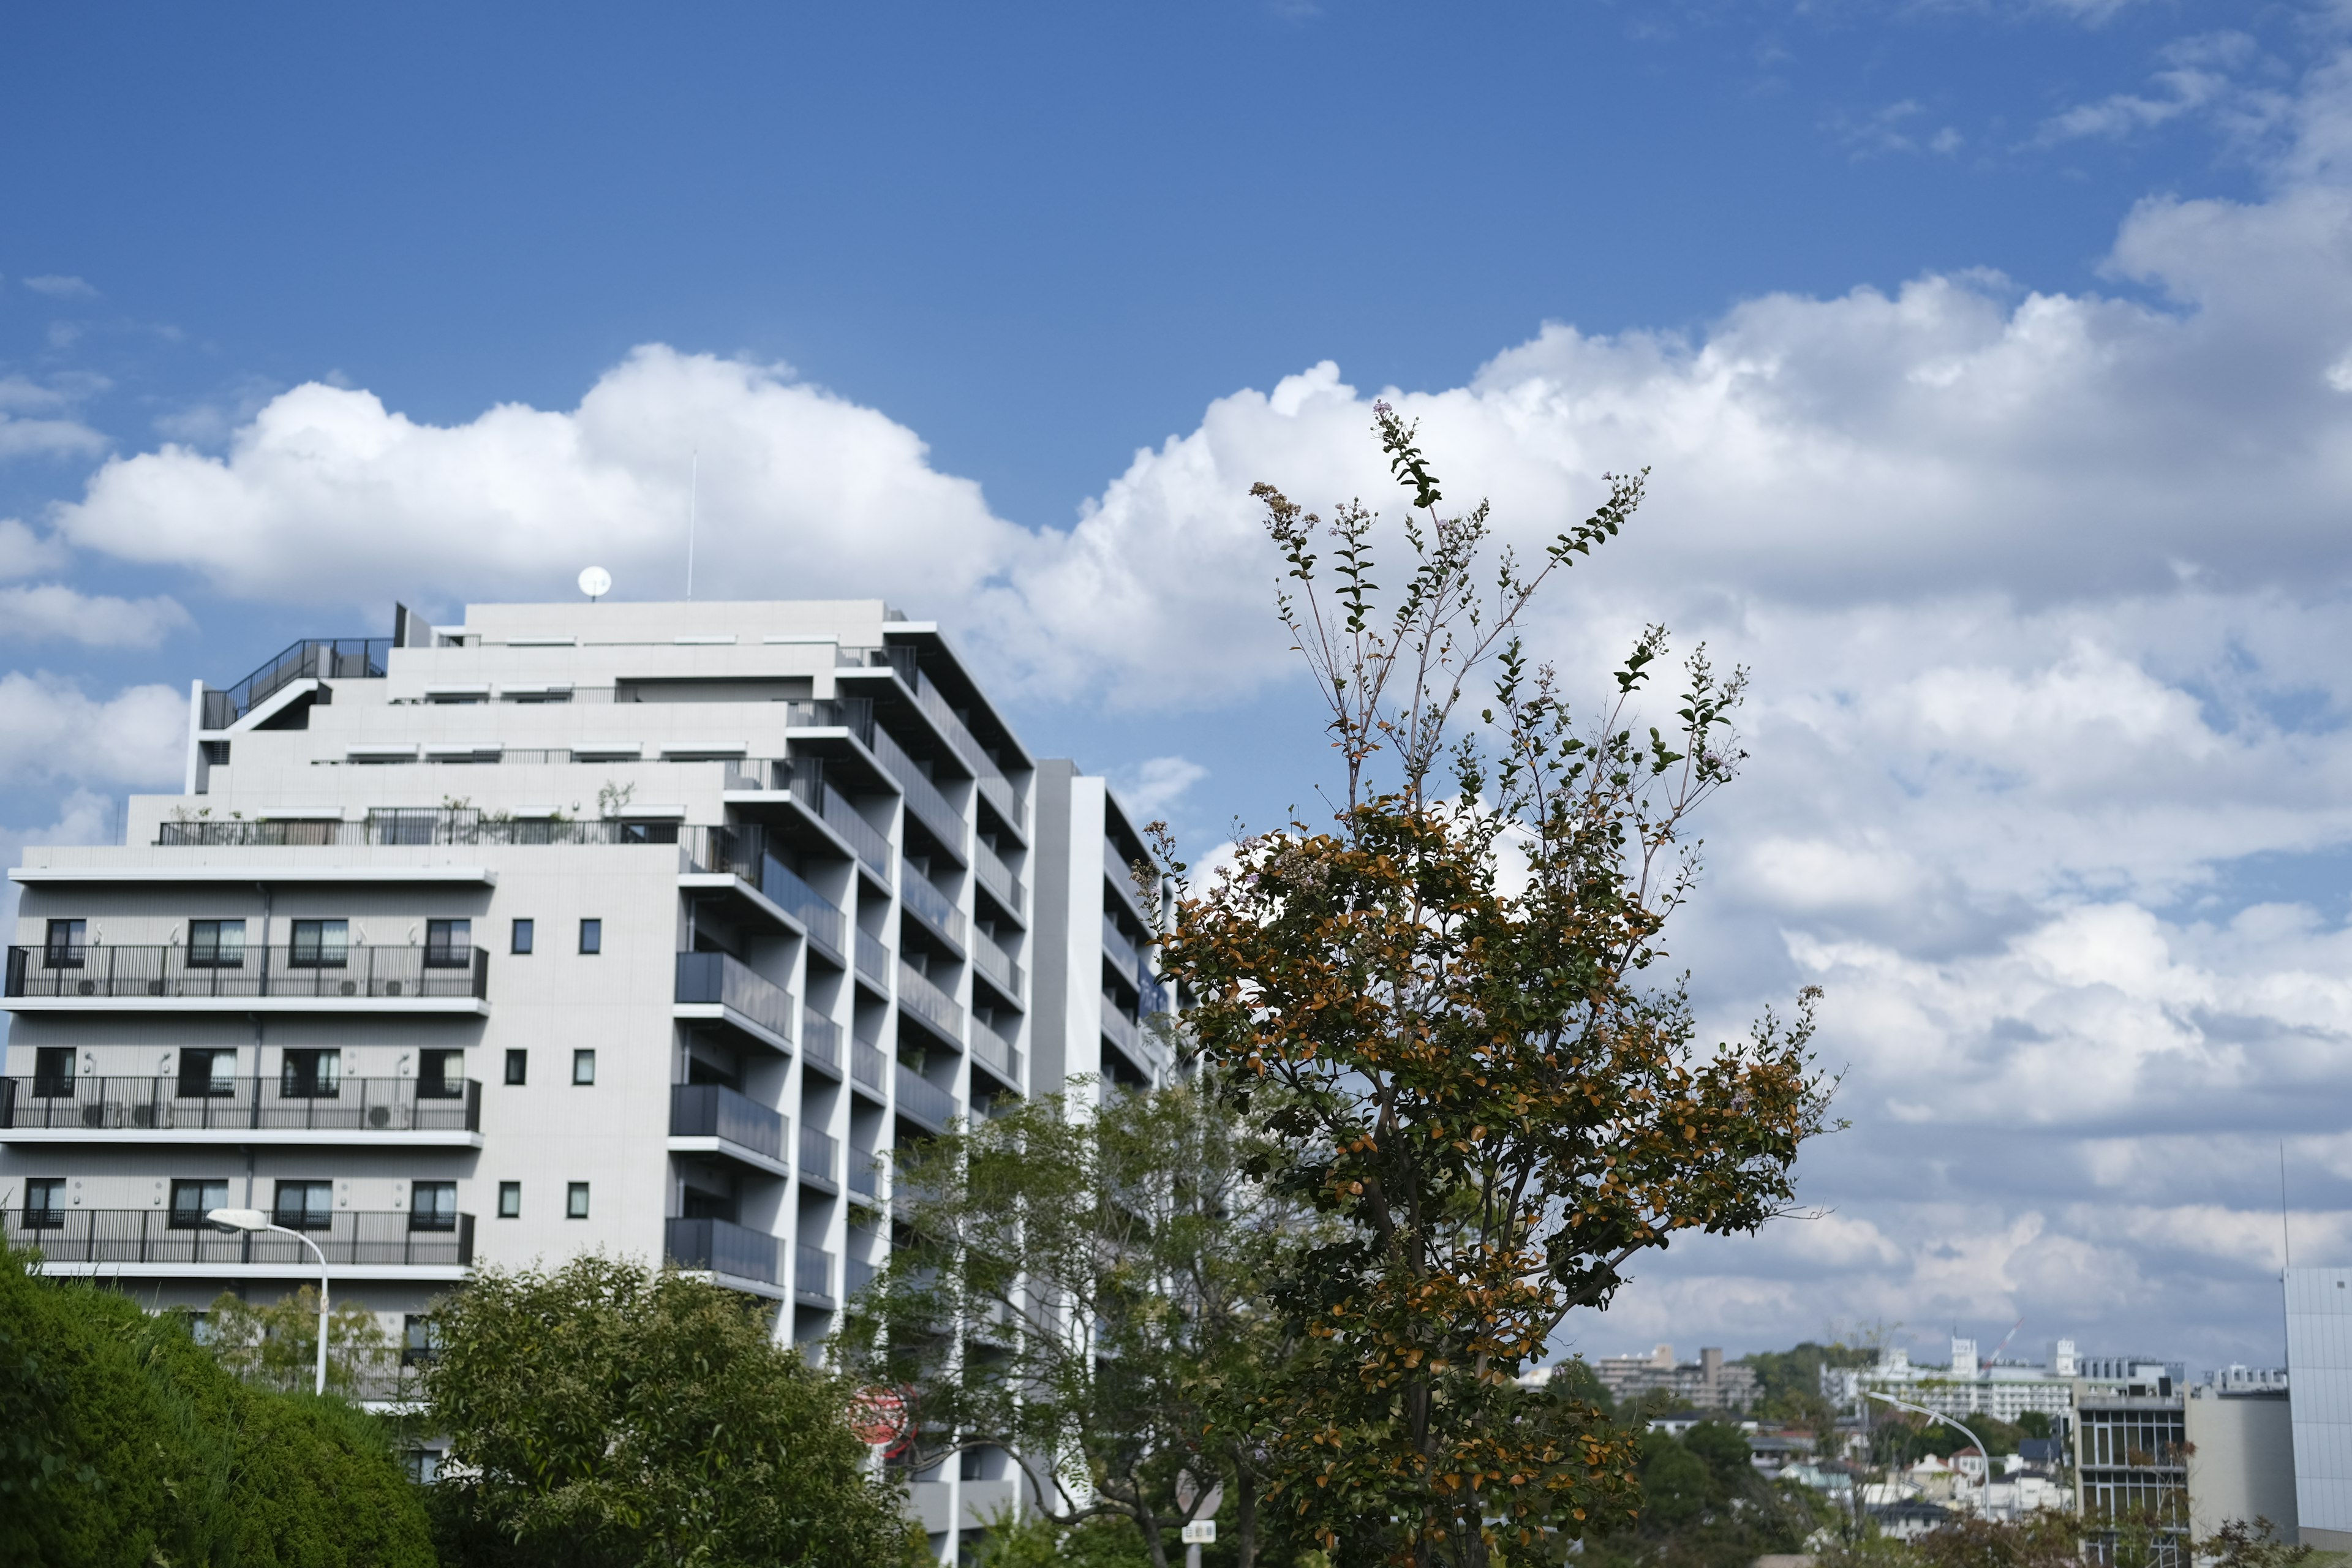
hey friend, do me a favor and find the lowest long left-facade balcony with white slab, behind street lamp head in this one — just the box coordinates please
[0,1208,473,1279]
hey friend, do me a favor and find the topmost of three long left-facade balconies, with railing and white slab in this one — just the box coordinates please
[7,943,489,1016]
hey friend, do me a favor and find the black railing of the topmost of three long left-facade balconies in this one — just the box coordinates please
[7,943,489,999]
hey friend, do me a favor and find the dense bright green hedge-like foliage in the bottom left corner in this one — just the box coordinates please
[0,1251,433,1568]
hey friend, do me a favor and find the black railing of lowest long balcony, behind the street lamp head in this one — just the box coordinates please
[5,1206,473,1276]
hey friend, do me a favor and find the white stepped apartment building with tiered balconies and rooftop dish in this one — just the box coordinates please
[0,602,1169,1551]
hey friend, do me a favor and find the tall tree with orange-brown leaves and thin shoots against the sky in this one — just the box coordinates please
[1162,404,1828,1568]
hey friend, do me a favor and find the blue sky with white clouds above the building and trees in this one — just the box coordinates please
[0,0,2352,1363]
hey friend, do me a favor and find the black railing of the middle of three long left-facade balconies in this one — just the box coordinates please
[0,1074,482,1133]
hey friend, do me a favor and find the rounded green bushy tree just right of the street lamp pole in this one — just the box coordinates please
[426,1256,929,1568]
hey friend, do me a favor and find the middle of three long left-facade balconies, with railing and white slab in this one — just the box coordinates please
[0,1074,482,1147]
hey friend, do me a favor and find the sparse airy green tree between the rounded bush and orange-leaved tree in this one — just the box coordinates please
[842,1084,1289,1568]
